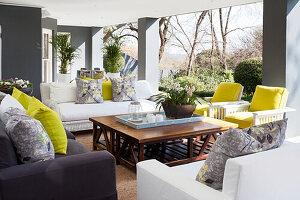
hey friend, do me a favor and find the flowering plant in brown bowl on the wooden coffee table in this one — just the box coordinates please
[153,79,198,119]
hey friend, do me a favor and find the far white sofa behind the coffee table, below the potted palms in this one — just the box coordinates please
[40,81,156,131]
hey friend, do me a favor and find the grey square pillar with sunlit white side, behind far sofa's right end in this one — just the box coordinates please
[138,18,160,93]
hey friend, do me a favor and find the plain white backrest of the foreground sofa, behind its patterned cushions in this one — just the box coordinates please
[223,142,300,200]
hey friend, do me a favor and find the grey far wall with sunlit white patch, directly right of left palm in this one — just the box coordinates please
[57,26,92,79]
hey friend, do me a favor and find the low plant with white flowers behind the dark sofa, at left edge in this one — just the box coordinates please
[0,78,32,95]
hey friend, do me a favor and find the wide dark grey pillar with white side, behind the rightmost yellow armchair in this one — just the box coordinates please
[263,0,300,137]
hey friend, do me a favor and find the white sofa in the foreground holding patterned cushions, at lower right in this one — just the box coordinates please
[137,140,300,200]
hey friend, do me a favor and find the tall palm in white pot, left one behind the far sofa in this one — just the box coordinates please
[51,34,78,83]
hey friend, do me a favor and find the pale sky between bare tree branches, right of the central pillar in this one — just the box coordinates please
[166,3,263,54]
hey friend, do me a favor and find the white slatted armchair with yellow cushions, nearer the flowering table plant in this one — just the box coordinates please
[195,83,248,119]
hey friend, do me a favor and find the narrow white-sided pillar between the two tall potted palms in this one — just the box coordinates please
[91,27,103,70]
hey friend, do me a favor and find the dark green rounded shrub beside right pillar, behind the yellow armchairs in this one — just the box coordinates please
[233,58,262,94]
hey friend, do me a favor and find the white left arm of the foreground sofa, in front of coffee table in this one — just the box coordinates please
[137,160,228,200]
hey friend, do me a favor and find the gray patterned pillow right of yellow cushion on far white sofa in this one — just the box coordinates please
[110,76,137,102]
